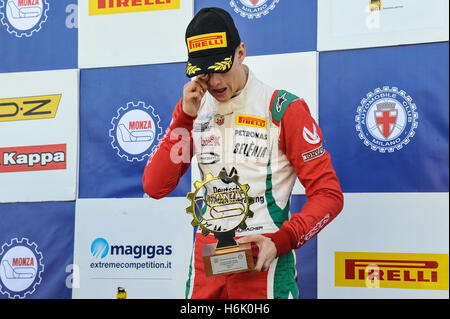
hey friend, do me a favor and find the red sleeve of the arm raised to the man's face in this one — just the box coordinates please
[143,99,195,199]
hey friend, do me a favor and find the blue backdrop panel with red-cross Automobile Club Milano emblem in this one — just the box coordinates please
[319,42,449,192]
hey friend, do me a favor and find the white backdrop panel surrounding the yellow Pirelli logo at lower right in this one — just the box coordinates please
[317,193,449,299]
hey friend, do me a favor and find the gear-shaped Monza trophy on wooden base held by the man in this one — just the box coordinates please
[186,169,255,277]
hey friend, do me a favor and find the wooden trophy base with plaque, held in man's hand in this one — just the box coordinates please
[203,243,255,277]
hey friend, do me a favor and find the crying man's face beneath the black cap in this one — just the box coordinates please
[198,44,246,102]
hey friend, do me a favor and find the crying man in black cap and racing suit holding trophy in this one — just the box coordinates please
[143,8,343,298]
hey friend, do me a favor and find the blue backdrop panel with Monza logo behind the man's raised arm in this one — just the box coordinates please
[79,63,191,198]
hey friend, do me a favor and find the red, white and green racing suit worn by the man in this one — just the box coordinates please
[143,71,343,298]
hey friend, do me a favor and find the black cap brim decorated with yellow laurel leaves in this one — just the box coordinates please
[186,51,234,78]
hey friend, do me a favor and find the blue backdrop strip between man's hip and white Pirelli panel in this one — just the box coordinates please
[291,195,317,299]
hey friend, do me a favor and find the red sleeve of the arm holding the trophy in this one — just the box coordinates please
[268,99,344,256]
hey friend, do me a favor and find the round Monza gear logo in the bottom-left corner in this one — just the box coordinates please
[0,238,44,299]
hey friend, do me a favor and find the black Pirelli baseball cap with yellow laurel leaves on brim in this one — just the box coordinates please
[186,7,241,78]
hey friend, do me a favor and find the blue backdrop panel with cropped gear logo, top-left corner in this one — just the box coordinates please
[0,0,78,72]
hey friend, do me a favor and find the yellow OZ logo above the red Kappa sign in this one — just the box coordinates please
[0,94,61,122]
